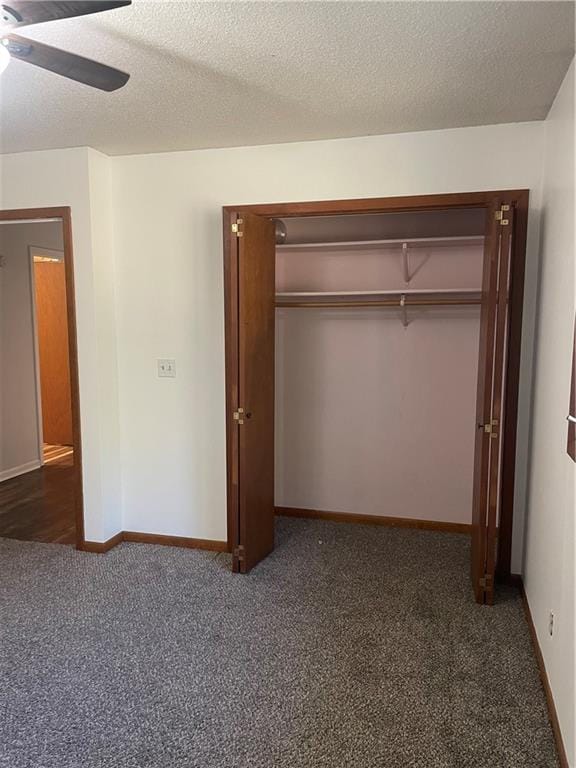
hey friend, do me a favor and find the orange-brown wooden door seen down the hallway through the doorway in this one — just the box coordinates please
[34,260,73,445]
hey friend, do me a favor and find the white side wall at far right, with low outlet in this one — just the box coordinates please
[524,64,576,766]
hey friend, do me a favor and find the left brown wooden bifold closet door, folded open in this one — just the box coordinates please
[233,213,276,573]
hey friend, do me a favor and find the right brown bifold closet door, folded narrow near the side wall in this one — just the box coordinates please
[471,200,514,604]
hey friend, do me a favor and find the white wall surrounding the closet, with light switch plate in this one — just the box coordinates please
[111,123,542,570]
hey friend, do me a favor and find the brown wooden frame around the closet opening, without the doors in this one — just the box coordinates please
[222,189,529,581]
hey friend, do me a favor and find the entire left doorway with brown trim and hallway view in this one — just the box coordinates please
[0,208,84,547]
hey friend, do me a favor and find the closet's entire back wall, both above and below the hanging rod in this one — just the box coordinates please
[275,211,484,524]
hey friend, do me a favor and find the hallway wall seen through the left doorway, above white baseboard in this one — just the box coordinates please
[0,222,62,479]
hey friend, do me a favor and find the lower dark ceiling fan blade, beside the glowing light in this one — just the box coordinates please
[1,35,130,91]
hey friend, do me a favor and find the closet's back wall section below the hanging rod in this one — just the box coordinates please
[275,308,480,524]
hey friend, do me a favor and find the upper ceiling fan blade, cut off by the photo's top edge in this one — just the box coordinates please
[0,0,132,27]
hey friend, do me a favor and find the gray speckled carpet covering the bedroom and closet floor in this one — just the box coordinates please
[0,519,557,768]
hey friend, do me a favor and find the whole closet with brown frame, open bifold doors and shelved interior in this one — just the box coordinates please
[224,192,527,603]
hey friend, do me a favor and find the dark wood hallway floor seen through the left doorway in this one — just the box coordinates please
[0,456,76,544]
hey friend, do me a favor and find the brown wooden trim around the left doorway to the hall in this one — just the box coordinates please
[0,206,86,550]
